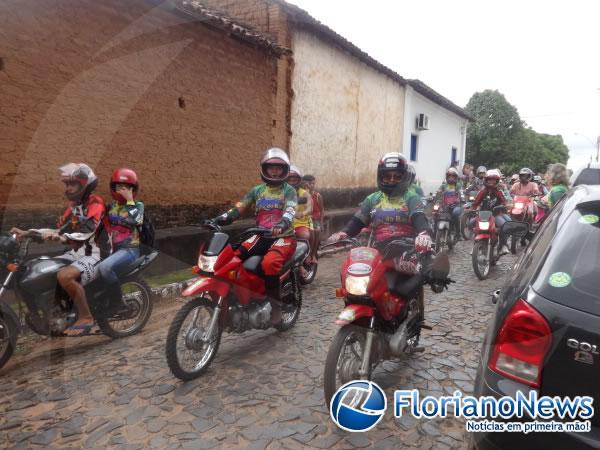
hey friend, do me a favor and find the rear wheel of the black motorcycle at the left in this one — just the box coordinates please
[97,279,153,339]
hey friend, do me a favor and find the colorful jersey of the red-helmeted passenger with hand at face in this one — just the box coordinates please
[105,201,144,252]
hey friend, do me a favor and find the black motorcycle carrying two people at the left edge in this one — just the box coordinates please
[0,230,158,368]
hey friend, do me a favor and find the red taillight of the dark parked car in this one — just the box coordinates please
[488,299,552,388]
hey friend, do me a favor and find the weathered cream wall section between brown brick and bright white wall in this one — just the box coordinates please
[290,31,405,188]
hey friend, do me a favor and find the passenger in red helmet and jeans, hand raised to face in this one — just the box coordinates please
[98,168,144,306]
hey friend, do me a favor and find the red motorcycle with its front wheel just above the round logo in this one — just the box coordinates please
[324,238,452,405]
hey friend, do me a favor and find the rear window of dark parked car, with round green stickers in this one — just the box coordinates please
[533,204,600,315]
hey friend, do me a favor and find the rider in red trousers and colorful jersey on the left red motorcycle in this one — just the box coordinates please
[213,147,298,323]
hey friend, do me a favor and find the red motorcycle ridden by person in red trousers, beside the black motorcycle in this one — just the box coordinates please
[166,222,309,381]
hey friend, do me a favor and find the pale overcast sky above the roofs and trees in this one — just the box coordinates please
[288,0,600,169]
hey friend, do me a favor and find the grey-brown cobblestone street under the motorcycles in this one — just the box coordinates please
[0,242,514,450]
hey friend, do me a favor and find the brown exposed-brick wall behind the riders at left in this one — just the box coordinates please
[0,0,282,228]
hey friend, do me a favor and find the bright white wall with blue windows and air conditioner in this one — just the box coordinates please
[403,86,467,194]
